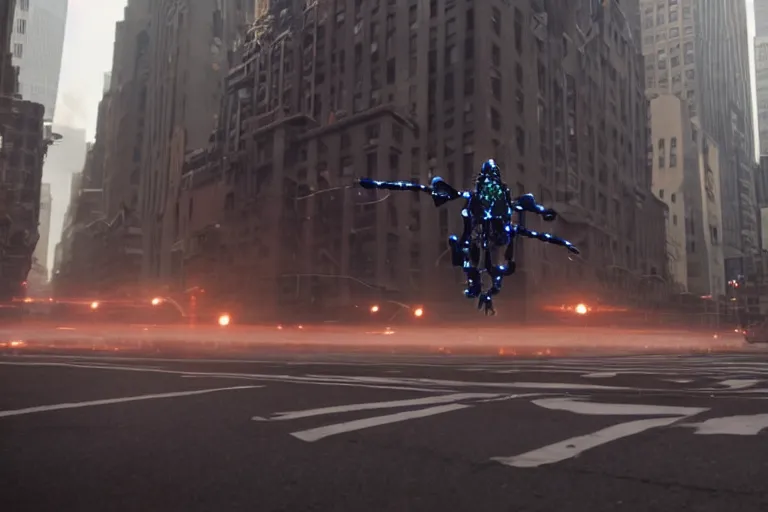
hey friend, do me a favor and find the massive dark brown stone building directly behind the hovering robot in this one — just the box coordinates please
[189,0,666,315]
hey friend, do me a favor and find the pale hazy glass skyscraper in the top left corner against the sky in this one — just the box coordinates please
[12,0,69,121]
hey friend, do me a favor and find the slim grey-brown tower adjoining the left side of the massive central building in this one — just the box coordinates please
[139,0,246,283]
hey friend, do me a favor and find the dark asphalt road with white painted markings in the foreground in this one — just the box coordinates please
[0,351,768,512]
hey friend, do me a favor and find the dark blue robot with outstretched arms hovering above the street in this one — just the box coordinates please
[359,160,579,315]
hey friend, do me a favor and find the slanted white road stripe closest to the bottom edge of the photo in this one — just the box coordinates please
[491,417,681,468]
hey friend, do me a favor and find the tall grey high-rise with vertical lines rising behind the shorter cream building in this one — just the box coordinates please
[640,0,759,288]
